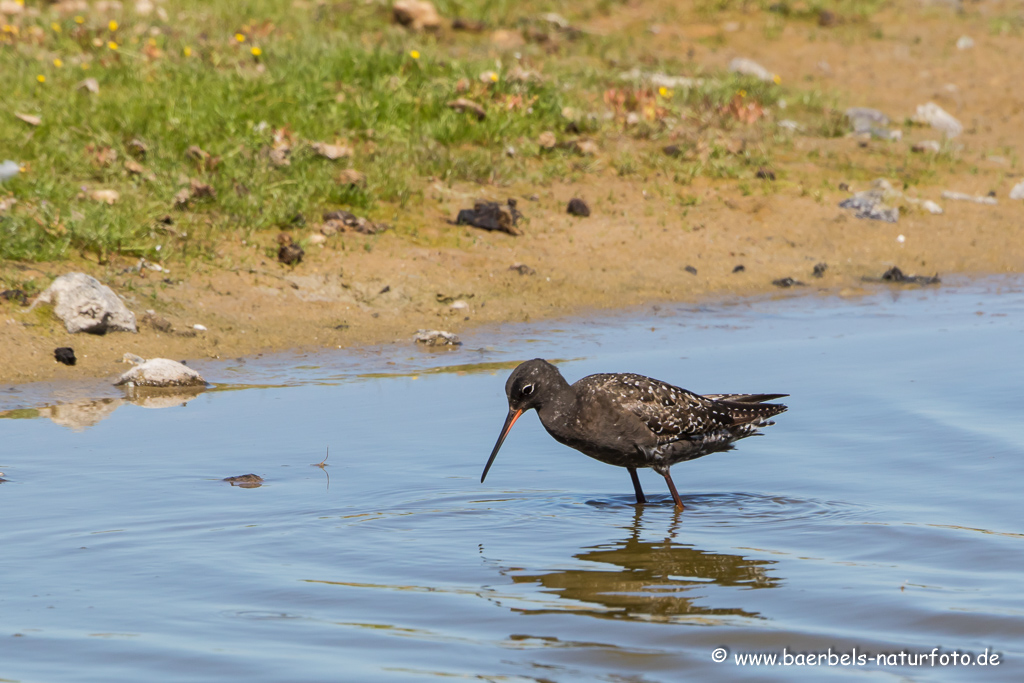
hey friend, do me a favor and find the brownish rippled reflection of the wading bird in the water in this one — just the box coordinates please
[503,509,780,618]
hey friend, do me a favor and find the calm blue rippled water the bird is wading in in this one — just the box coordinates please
[0,281,1024,682]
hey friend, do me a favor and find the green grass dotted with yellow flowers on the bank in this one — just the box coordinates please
[0,0,839,261]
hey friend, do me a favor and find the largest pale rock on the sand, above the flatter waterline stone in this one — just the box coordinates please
[32,272,138,335]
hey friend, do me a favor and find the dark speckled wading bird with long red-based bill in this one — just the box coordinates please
[480,358,788,509]
